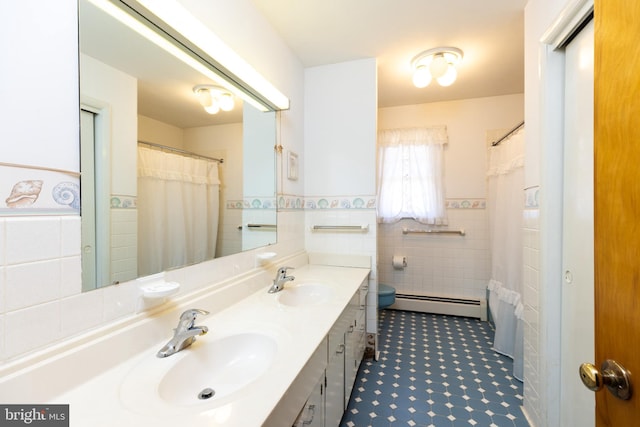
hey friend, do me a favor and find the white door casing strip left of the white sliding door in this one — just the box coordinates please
[536,0,594,425]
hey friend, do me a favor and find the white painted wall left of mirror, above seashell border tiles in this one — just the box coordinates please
[0,0,80,171]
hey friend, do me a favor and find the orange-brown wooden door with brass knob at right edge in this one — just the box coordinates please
[594,0,640,427]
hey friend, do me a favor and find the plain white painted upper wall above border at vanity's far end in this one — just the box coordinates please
[301,59,377,196]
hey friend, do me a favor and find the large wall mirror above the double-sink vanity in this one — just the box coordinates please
[79,0,278,291]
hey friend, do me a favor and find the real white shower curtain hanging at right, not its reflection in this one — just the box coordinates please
[487,129,524,380]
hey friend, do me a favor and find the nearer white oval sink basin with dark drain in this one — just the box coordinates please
[120,332,277,413]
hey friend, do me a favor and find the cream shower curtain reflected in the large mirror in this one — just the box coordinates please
[138,146,220,276]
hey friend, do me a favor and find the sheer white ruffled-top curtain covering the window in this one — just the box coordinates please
[377,126,448,225]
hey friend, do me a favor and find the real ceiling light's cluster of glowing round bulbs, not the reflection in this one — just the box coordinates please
[411,47,463,88]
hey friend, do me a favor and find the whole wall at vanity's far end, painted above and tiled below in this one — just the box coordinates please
[299,59,378,333]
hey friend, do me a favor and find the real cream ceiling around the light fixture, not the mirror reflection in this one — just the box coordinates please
[250,0,527,107]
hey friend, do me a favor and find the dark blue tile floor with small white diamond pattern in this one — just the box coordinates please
[340,310,529,427]
